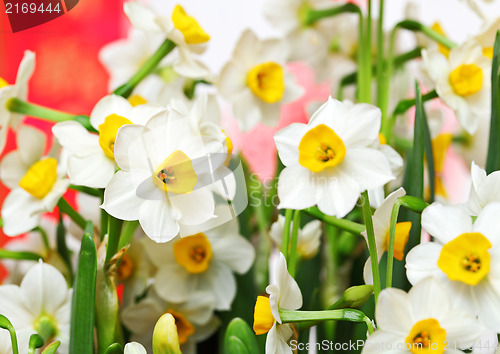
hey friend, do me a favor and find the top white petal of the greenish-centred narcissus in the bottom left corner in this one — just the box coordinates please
[20,263,68,316]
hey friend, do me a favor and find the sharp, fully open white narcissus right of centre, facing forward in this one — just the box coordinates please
[274,98,394,218]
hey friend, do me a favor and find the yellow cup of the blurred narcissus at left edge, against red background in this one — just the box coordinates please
[19,157,57,199]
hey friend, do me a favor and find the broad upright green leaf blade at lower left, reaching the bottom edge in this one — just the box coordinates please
[69,221,97,354]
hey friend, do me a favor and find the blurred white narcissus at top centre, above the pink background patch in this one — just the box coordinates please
[217,30,303,131]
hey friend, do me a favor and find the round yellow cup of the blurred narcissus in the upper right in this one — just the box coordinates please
[449,64,483,97]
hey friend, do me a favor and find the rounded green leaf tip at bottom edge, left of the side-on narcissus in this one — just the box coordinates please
[224,318,260,354]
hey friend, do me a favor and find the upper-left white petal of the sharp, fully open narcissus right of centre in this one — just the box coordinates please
[274,123,308,166]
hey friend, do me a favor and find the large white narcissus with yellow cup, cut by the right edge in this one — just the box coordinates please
[406,203,500,332]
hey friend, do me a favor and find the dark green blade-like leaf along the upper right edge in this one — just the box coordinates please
[486,31,500,174]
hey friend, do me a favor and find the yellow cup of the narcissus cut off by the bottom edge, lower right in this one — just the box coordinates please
[406,318,446,354]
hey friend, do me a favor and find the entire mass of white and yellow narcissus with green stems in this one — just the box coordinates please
[0,0,500,354]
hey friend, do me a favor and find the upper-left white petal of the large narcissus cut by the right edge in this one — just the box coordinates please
[422,203,472,244]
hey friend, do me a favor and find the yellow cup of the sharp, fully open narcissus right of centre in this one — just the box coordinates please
[299,124,346,172]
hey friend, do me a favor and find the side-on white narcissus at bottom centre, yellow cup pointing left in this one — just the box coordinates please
[253,253,302,354]
